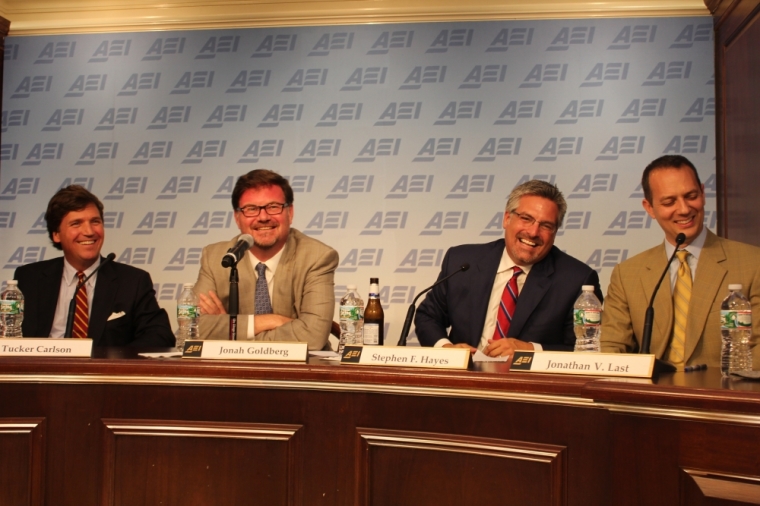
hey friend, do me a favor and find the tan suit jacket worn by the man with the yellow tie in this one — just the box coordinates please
[601,230,760,368]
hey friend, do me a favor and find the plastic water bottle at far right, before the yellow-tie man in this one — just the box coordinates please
[720,284,752,377]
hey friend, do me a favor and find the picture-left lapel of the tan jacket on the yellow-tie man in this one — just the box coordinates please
[637,243,673,357]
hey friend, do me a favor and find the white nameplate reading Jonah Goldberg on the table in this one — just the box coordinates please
[182,340,309,363]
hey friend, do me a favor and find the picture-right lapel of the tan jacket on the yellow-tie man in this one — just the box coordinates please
[684,230,726,360]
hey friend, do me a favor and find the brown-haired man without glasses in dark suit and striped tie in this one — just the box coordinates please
[14,185,174,347]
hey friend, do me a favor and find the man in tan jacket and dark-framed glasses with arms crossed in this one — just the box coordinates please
[194,169,338,350]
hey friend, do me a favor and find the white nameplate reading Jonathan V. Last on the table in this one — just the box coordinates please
[510,351,654,378]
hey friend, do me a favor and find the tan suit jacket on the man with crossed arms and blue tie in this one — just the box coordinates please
[194,229,338,350]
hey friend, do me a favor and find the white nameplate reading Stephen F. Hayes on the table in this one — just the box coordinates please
[340,346,470,369]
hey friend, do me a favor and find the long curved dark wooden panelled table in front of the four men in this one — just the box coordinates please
[0,349,760,506]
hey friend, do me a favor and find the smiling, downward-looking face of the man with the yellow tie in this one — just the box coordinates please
[642,167,705,245]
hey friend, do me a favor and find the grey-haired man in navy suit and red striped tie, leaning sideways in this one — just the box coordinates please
[414,180,602,357]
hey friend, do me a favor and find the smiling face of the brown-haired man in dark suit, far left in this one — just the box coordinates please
[53,204,105,271]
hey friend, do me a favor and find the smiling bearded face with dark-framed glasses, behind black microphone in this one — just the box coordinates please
[235,186,293,261]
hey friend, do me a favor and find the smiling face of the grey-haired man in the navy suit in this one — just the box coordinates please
[503,195,559,266]
